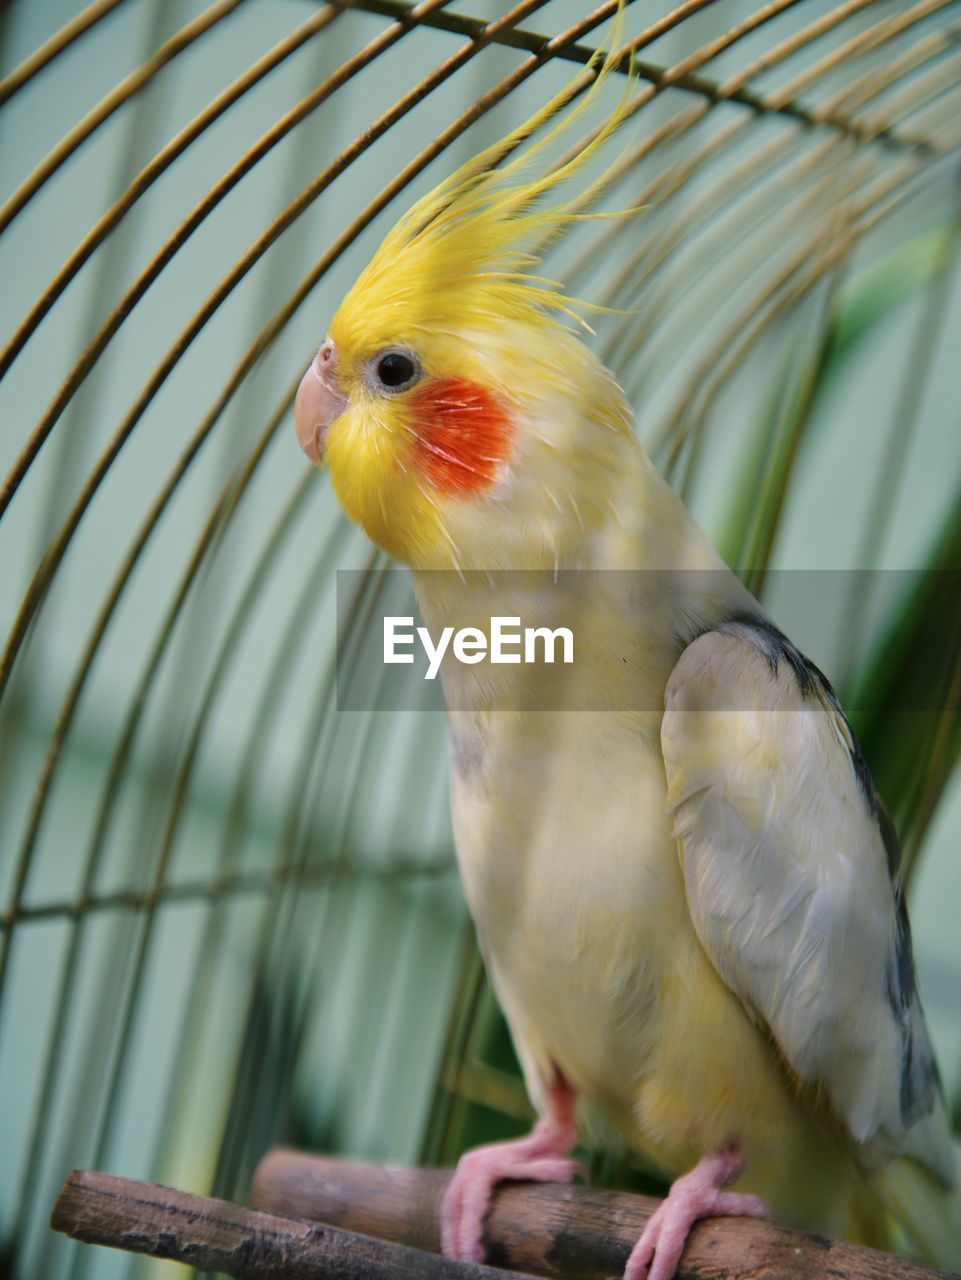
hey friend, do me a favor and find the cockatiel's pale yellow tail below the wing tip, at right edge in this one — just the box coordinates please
[873,1142,961,1274]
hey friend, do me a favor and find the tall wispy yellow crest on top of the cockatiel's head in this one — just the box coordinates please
[330,28,633,366]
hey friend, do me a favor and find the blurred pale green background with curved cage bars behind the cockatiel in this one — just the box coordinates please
[0,0,961,1280]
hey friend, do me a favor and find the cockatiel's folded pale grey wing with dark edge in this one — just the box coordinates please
[662,617,953,1185]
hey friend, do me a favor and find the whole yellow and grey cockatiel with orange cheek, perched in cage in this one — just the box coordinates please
[294,32,961,1280]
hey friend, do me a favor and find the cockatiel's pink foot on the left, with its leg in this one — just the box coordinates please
[440,1075,584,1262]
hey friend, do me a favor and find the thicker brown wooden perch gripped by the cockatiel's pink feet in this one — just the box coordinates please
[251,1151,961,1280]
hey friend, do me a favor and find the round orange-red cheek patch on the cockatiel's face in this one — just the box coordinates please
[408,378,511,493]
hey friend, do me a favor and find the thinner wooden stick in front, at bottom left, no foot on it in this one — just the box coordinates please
[50,1170,535,1280]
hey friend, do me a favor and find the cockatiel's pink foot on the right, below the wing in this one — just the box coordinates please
[624,1147,772,1280]
